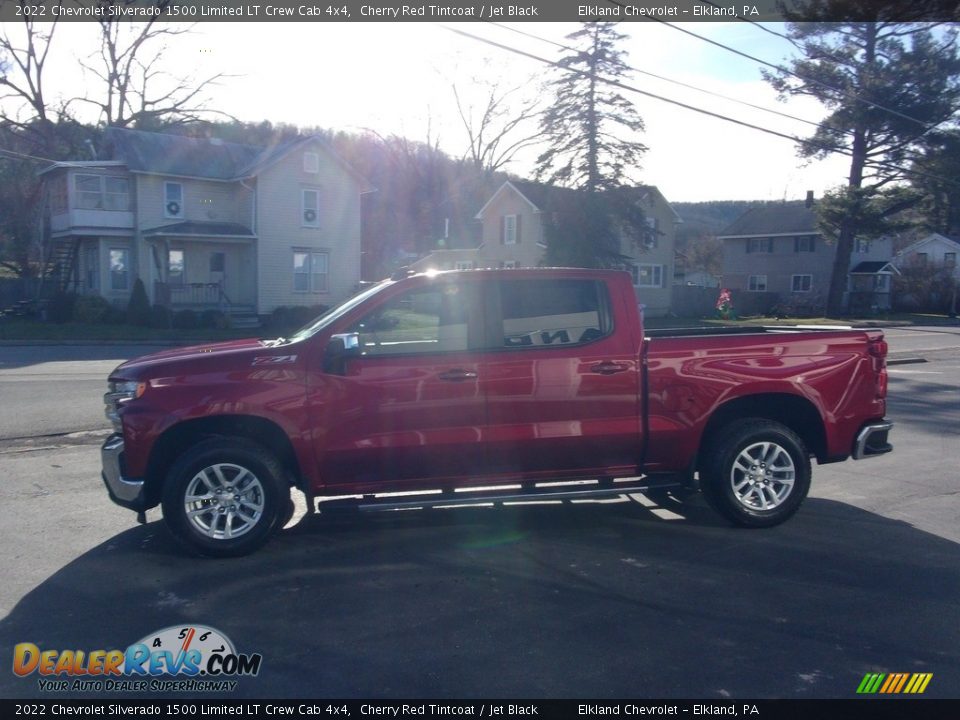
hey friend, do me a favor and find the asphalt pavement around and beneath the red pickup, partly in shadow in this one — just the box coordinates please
[0,328,960,700]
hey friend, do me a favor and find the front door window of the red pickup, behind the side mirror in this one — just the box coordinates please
[350,283,476,357]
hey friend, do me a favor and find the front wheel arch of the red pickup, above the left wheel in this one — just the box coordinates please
[140,415,303,505]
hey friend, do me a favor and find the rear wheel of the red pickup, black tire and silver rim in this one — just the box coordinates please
[700,418,811,528]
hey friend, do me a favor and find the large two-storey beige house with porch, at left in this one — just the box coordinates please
[42,128,370,324]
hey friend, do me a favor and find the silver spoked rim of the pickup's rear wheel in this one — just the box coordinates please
[730,442,797,512]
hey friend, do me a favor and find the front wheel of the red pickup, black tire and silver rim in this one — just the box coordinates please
[163,438,289,557]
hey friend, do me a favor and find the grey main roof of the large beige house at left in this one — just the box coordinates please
[106,128,263,180]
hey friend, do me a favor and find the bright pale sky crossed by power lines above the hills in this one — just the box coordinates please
[4,22,848,202]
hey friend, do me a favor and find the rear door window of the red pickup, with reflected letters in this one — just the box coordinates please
[500,279,612,348]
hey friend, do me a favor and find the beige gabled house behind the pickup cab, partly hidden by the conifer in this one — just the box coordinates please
[413,180,680,316]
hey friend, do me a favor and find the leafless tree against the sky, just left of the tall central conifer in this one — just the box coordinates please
[451,81,543,174]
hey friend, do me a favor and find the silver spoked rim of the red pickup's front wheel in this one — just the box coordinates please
[183,463,265,540]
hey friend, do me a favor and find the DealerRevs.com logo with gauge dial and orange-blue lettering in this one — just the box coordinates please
[13,625,263,692]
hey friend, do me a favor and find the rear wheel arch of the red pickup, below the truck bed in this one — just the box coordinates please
[700,393,827,463]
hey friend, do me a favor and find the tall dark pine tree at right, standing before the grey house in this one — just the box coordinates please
[765,0,960,315]
